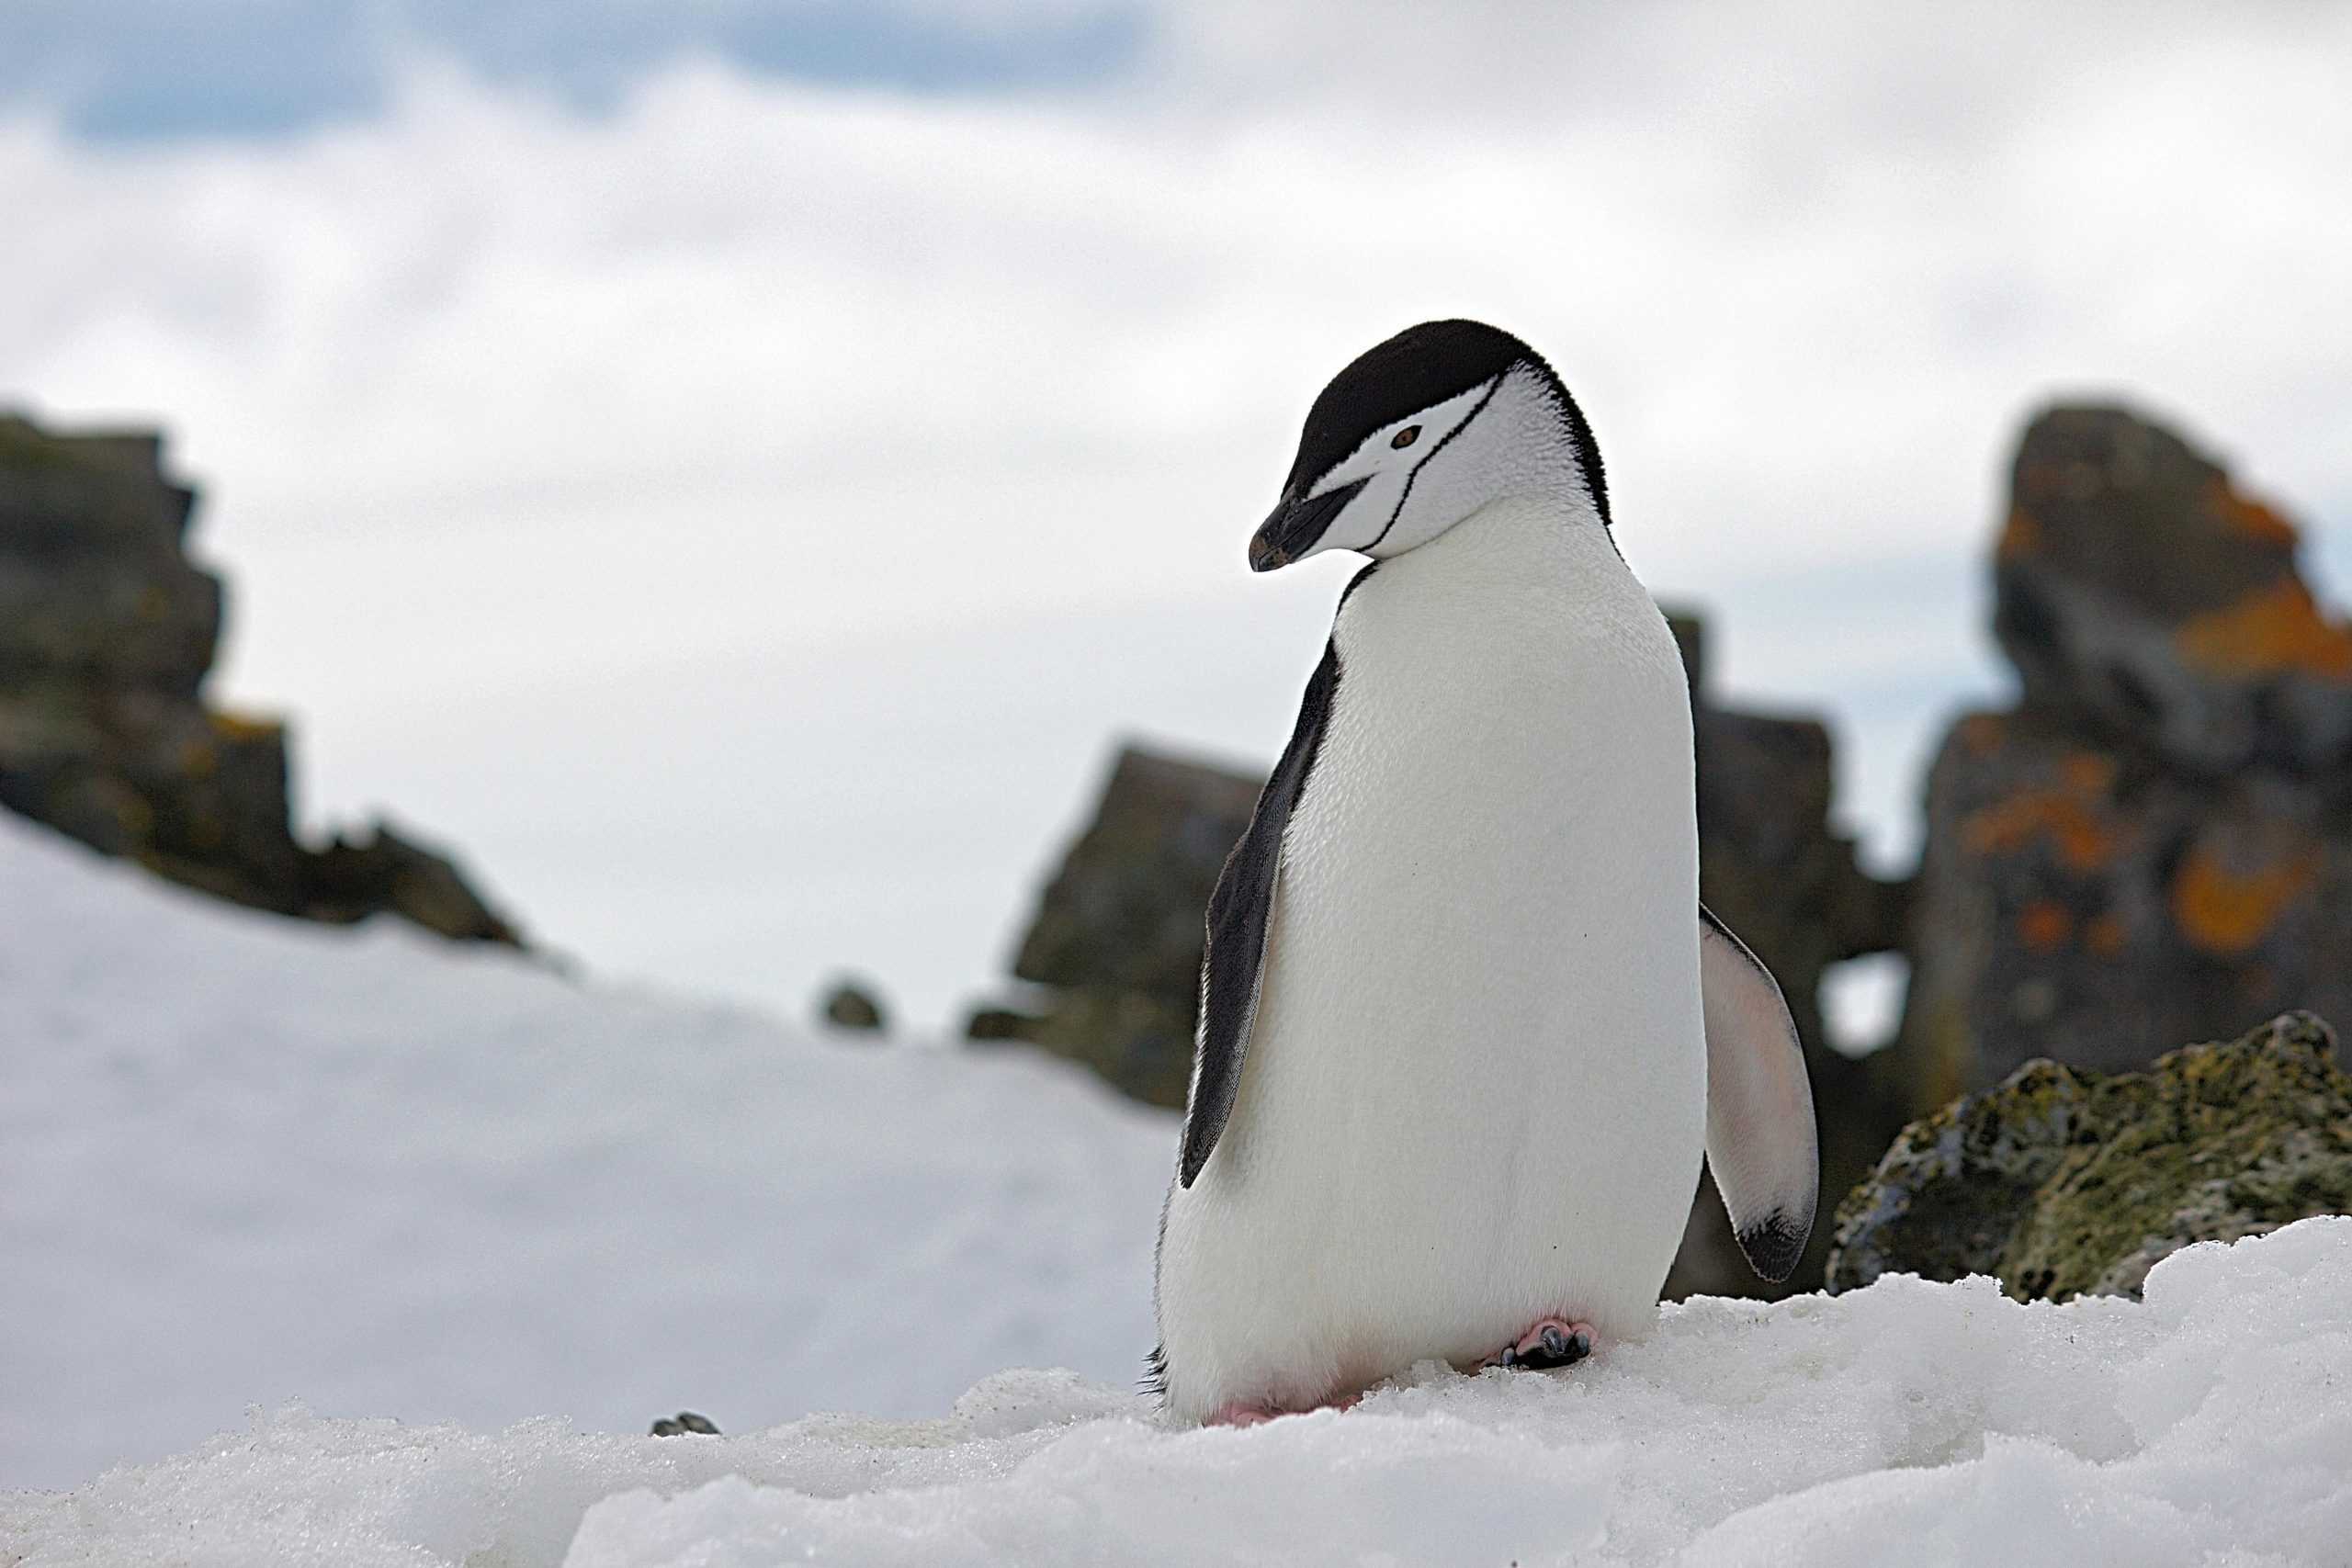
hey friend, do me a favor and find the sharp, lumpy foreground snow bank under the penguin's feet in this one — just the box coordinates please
[0,1218,2352,1568]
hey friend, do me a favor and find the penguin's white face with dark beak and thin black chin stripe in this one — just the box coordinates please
[1251,369,1580,571]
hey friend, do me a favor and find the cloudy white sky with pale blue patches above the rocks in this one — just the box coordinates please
[0,0,2352,1030]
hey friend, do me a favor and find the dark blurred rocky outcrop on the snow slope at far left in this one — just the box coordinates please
[0,416,517,942]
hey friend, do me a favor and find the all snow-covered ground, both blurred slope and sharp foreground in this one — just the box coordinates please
[0,818,2352,1568]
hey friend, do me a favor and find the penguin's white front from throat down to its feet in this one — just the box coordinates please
[1159,503,1705,1417]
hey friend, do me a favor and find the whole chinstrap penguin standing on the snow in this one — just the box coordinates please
[1152,320,1815,1425]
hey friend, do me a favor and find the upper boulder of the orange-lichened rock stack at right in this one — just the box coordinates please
[1995,407,2352,773]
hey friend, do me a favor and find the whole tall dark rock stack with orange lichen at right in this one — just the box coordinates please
[1900,407,2352,1112]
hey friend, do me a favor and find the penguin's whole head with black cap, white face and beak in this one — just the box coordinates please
[1249,322,1609,571]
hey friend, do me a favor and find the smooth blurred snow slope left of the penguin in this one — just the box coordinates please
[0,813,1176,1495]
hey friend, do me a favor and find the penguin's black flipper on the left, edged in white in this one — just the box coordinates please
[1179,644,1339,1187]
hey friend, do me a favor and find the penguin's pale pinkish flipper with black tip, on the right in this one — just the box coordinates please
[1698,905,1820,1283]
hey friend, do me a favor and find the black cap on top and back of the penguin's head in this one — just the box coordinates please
[1282,320,1609,526]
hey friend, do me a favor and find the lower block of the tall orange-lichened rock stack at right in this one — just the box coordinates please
[1900,712,2352,1110]
